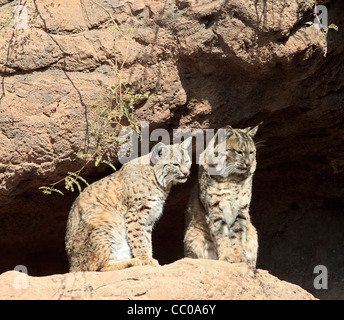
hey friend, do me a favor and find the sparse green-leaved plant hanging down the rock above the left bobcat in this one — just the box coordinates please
[39,19,150,195]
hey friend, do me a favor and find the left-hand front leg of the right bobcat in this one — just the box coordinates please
[207,202,246,263]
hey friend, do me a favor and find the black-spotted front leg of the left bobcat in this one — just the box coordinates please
[125,208,159,267]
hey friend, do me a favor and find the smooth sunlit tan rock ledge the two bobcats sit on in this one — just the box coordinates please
[0,258,315,300]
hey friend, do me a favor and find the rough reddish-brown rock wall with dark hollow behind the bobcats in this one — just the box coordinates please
[0,0,344,299]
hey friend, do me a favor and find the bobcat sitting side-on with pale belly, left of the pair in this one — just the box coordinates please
[65,138,191,272]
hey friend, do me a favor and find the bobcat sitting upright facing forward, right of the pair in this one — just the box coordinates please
[184,125,259,267]
